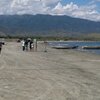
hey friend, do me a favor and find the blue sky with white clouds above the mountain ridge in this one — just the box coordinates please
[0,0,100,21]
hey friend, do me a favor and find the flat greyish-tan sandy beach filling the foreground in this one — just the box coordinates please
[0,42,100,100]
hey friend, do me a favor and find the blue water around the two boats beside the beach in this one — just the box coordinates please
[48,41,100,55]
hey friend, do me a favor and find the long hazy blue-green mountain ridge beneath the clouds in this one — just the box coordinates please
[0,15,100,36]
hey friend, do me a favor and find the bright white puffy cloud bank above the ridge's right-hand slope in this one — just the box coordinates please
[52,2,100,21]
